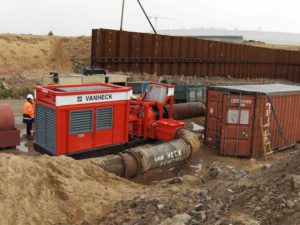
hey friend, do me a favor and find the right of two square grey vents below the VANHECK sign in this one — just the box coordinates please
[97,107,113,130]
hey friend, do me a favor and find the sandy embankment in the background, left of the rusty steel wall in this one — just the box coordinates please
[0,34,91,79]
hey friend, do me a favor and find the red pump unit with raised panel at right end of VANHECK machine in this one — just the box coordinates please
[129,82,184,141]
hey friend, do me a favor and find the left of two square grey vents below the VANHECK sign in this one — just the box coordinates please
[70,110,93,134]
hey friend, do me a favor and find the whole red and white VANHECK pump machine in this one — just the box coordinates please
[35,82,184,155]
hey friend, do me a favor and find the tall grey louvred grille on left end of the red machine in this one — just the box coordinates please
[35,104,56,155]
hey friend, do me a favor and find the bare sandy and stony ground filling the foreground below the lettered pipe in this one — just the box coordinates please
[0,100,300,225]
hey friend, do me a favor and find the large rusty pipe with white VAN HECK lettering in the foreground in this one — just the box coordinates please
[90,129,200,178]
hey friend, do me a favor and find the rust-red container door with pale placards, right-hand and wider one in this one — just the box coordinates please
[220,93,255,157]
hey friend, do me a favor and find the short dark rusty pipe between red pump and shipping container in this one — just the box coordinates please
[173,102,206,120]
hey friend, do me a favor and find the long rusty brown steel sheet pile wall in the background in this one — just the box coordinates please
[91,29,300,81]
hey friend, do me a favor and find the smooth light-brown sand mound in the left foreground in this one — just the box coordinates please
[0,154,140,224]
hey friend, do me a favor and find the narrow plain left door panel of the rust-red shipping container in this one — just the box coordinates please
[205,90,224,148]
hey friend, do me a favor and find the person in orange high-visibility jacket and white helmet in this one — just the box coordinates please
[23,94,35,139]
